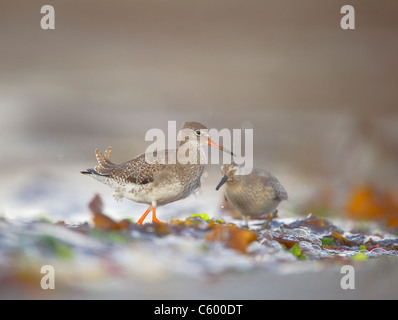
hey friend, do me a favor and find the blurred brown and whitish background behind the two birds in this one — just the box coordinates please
[0,0,398,221]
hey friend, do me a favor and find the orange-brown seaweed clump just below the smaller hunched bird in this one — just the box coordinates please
[205,224,257,253]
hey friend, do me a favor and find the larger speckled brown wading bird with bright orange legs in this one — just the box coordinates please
[81,122,232,225]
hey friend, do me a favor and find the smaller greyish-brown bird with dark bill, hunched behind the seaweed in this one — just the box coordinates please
[216,163,288,228]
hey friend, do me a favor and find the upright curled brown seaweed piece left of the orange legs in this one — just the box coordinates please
[89,194,130,230]
